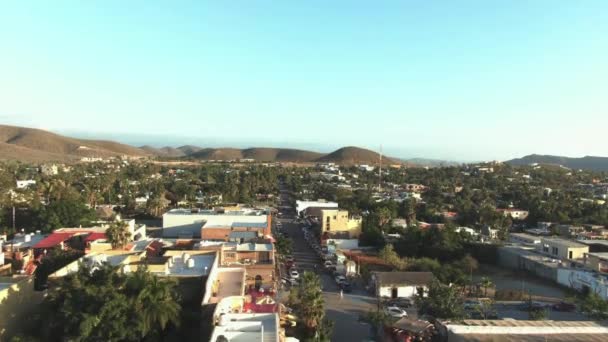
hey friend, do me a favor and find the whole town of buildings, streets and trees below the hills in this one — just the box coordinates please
[0,157,608,341]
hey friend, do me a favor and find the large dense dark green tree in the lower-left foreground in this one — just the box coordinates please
[40,265,181,341]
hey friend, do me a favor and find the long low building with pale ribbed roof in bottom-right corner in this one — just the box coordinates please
[436,319,608,342]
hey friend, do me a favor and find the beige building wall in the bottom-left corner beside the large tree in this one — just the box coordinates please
[0,277,42,341]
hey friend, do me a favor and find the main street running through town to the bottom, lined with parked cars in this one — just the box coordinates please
[279,187,376,342]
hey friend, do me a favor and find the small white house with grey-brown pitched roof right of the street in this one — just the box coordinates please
[371,272,434,298]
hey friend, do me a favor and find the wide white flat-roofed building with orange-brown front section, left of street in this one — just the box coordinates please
[163,208,272,241]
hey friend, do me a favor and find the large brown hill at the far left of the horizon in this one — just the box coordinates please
[0,125,149,162]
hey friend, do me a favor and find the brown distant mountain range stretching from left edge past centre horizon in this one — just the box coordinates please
[0,125,394,165]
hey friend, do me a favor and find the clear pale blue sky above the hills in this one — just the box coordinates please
[0,0,608,160]
